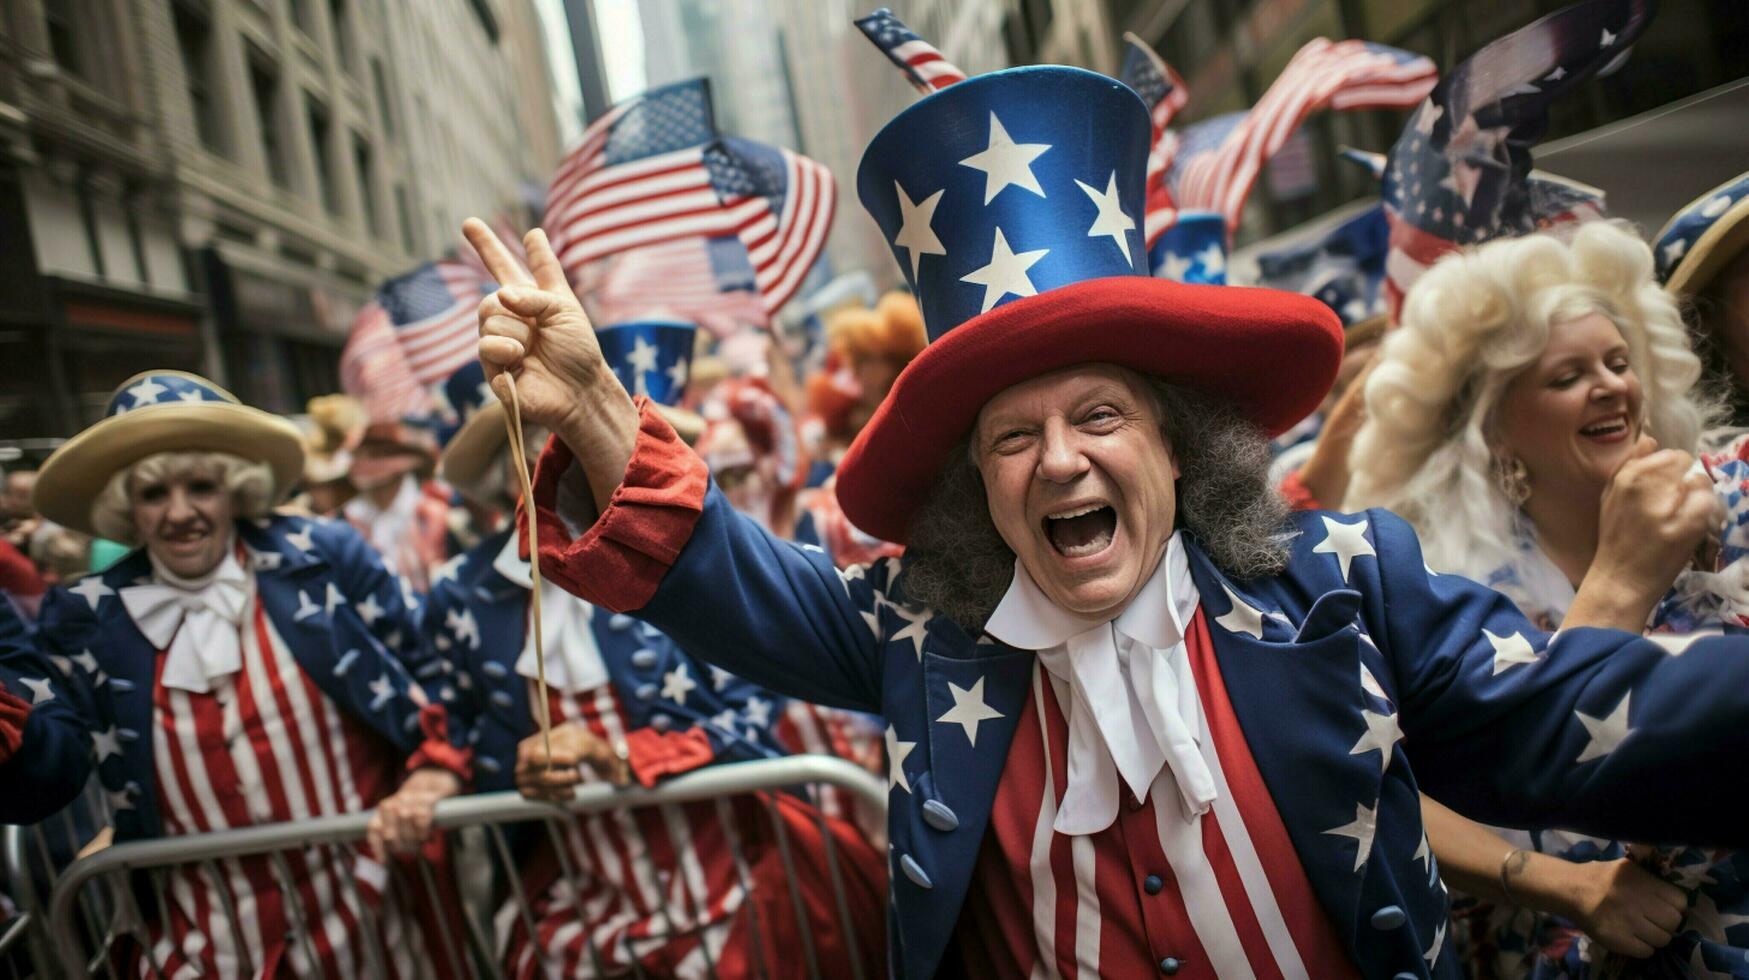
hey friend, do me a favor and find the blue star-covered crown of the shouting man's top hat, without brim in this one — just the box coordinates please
[857,67,1151,341]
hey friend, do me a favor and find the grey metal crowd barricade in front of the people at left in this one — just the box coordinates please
[47,754,887,980]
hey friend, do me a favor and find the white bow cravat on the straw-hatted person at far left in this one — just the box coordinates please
[121,544,250,695]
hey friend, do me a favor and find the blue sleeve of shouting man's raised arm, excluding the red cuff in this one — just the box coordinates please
[637,483,897,712]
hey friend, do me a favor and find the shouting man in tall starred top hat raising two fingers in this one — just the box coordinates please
[469,55,1749,978]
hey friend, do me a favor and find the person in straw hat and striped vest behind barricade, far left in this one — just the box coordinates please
[0,371,467,977]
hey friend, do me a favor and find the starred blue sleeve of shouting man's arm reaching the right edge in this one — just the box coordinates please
[1354,511,1749,845]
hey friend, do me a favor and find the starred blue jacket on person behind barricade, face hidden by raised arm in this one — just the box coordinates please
[416,530,804,791]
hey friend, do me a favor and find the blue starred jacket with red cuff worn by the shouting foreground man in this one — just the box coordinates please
[535,413,1749,978]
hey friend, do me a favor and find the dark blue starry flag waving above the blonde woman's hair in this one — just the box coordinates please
[1382,0,1653,315]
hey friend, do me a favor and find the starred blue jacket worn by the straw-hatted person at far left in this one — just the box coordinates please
[0,516,465,840]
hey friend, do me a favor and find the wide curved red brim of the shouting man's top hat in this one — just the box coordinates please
[838,277,1341,543]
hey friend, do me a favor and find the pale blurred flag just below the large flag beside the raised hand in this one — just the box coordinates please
[579,238,770,338]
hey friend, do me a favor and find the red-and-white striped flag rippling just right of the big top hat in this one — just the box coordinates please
[1151,37,1438,235]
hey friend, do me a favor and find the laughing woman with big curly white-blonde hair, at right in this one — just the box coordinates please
[1345,222,1742,977]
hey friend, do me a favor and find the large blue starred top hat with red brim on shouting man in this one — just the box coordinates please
[838,65,1341,541]
